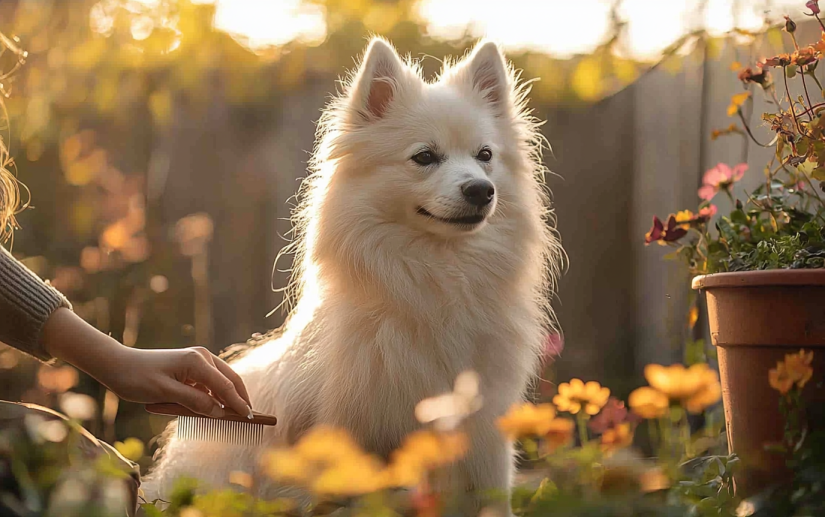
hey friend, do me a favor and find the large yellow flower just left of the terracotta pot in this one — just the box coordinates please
[645,363,722,413]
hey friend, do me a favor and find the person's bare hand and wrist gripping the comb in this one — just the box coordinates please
[42,309,252,418]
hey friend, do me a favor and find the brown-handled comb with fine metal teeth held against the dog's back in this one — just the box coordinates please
[146,403,278,445]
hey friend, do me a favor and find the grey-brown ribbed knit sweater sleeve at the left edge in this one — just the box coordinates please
[0,246,71,361]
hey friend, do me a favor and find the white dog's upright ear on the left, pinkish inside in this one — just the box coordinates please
[349,38,404,122]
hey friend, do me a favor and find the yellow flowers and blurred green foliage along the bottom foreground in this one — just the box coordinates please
[0,351,825,517]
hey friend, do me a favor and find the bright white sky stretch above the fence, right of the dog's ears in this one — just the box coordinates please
[420,0,804,59]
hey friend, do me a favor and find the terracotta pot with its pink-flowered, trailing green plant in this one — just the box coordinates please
[645,0,825,495]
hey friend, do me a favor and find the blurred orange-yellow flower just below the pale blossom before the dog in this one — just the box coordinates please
[388,431,468,486]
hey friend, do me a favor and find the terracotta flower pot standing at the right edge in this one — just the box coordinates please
[693,269,825,497]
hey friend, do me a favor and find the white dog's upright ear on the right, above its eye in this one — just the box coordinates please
[458,41,512,115]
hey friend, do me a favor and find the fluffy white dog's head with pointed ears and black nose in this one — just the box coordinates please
[318,38,529,237]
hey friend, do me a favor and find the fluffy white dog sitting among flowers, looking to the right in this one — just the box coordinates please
[144,38,563,513]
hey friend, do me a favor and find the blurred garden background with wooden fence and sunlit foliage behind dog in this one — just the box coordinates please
[0,0,819,452]
